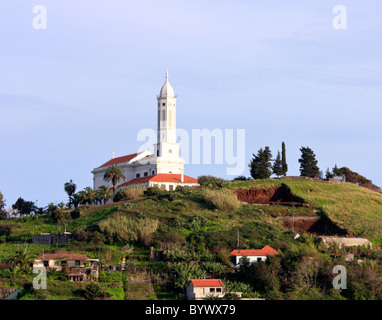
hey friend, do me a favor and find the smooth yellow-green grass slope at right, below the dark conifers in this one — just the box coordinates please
[230,178,382,245]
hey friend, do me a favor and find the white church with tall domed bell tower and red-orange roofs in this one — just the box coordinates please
[92,72,199,191]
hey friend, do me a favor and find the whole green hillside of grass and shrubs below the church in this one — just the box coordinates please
[0,179,382,299]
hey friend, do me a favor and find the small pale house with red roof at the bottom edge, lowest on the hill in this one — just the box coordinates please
[186,279,224,300]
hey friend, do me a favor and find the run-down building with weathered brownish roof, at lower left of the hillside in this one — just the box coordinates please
[33,252,100,281]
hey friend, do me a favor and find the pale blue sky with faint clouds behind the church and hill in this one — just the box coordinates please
[0,0,382,207]
